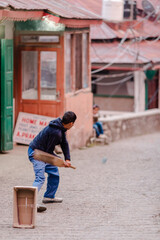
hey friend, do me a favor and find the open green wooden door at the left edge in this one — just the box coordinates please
[0,39,13,151]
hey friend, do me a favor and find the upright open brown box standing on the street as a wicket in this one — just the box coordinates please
[13,186,37,228]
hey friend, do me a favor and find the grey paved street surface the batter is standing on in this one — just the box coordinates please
[0,132,160,240]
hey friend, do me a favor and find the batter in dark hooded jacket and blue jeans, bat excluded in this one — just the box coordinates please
[28,111,77,212]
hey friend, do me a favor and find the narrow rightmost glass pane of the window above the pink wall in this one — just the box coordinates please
[83,33,88,88]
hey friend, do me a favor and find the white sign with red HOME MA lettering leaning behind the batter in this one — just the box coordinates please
[13,112,54,145]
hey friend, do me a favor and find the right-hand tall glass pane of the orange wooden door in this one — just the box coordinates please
[41,51,57,100]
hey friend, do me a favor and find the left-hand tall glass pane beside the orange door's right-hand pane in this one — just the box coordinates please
[22,51,38,99]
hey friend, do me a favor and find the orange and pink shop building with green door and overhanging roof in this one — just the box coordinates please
[0,1,101,151]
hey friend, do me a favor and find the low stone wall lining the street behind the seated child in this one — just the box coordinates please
[99,109,160,142]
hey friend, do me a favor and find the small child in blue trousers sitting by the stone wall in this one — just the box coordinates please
[93,104,105,138]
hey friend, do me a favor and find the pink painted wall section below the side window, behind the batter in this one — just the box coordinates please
[65,90,93,149]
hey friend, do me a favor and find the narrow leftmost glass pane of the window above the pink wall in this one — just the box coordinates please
[65,34,72,92]
